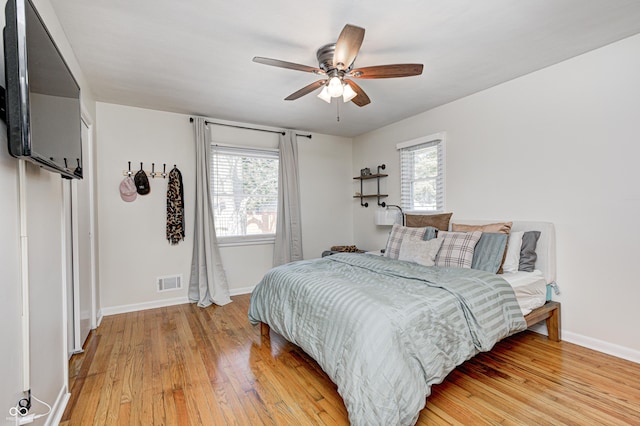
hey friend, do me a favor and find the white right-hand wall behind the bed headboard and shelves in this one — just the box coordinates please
[353,36,640,361]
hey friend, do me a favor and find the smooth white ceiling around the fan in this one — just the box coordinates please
[51,0,640,137]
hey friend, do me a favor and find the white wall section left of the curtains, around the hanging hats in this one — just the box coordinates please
[96,103,195,309]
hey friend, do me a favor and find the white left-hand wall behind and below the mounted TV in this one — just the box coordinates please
[0,0,95,424]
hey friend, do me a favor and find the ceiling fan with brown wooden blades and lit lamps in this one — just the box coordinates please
[253,24,423,107]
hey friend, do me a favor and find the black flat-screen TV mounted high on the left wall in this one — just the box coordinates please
[3,0,82,179]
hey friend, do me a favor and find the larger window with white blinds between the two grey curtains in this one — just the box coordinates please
[210,144,278,243]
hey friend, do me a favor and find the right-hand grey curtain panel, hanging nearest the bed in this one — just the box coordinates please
[273,131,302,266]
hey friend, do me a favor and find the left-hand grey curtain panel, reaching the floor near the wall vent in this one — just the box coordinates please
[189,118,231,308]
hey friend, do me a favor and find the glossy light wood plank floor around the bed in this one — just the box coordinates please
[61,295,640,425]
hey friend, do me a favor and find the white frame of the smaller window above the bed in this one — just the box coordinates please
[396,132,446,214]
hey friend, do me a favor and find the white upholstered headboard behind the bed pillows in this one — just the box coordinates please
[451,218,556,284]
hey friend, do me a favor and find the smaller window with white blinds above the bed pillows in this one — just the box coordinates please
[396,133,444,212]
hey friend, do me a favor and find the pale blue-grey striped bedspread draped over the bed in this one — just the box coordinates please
[249,253,526,426]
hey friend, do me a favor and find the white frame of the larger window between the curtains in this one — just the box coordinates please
[209,141,280,247]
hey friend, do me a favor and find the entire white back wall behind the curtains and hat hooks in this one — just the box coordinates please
[97,103,353,314]
